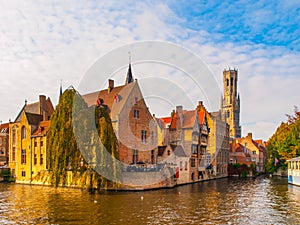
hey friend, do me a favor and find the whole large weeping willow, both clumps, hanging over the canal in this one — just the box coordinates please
[47,89,119,188]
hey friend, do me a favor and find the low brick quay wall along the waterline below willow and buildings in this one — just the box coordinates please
[11,167,228,192]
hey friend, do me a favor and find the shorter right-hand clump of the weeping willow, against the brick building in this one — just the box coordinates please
[74,106,121,188]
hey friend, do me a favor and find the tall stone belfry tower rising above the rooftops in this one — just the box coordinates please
[221,69,241,138]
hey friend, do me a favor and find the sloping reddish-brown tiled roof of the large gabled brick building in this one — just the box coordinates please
[82,82,137,119]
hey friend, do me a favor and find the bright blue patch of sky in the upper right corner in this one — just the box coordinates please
[169,1,300,51]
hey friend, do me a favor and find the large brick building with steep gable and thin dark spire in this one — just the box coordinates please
[82,64,157,164]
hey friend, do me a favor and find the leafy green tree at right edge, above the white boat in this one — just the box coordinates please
[266,107,300,173]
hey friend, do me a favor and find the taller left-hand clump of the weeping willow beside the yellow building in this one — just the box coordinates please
[47,89,86,187]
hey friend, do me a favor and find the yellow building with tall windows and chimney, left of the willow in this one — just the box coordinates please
[9,95,54,183]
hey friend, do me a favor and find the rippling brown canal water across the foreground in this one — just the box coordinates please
[0,177,300,225]
